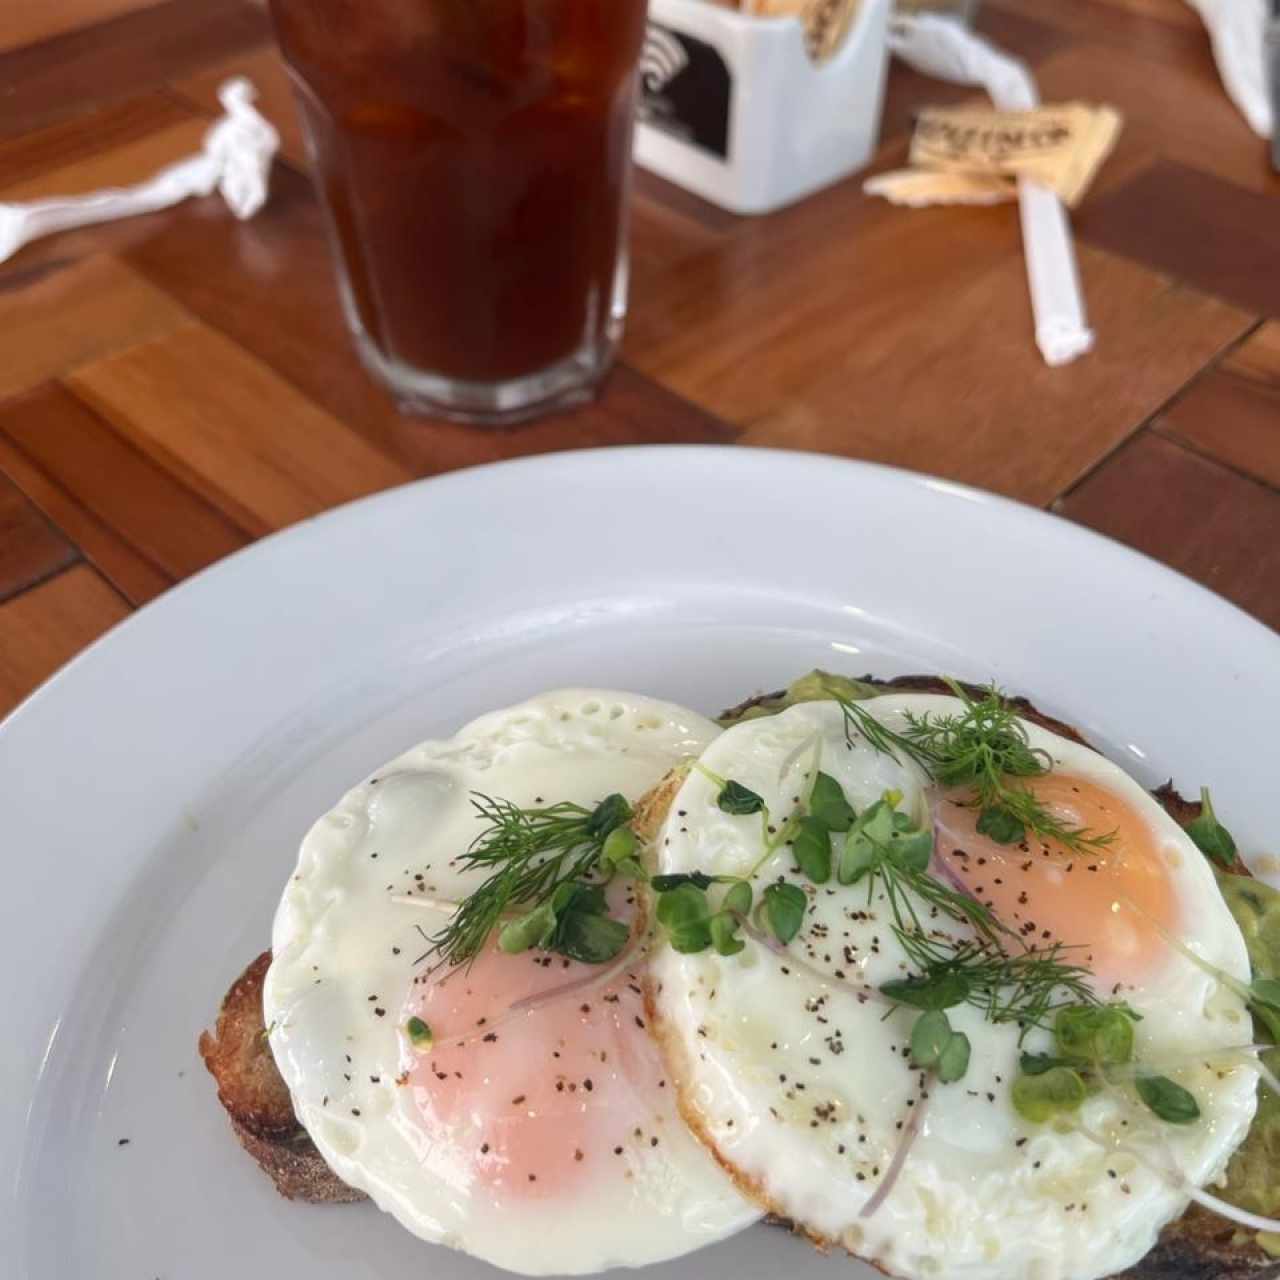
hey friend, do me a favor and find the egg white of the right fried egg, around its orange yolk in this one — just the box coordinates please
[650,695,1257,1280]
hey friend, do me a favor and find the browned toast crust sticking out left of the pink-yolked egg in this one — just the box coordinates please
[200,951,365,1204]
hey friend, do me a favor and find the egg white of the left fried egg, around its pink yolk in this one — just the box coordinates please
[264,689,759,1275]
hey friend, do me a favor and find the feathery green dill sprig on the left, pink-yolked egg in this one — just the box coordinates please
[428,791,631,965]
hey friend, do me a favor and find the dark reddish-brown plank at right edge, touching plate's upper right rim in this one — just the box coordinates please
[1055,433,1280,627]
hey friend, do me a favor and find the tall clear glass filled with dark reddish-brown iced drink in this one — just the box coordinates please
[271,0,645,422]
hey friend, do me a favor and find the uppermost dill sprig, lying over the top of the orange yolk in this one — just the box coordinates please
[836,680,1115,854]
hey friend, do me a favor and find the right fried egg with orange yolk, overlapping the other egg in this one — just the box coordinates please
[649,695,1257,1280]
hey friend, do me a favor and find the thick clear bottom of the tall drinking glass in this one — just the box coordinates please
[351,323,622,426]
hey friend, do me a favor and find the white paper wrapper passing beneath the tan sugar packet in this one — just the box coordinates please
[890,14,1093,365]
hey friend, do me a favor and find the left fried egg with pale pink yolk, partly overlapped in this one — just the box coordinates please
[264,690,759,1275]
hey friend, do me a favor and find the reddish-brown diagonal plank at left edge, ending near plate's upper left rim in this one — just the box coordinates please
[0,384,250,603]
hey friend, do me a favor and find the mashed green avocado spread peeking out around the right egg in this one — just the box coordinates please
[719,671,1280,1257]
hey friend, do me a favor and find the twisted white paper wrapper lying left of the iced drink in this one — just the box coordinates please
[0,77,280,262]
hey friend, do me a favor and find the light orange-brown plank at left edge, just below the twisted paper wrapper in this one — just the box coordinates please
[0,257,189,398]
